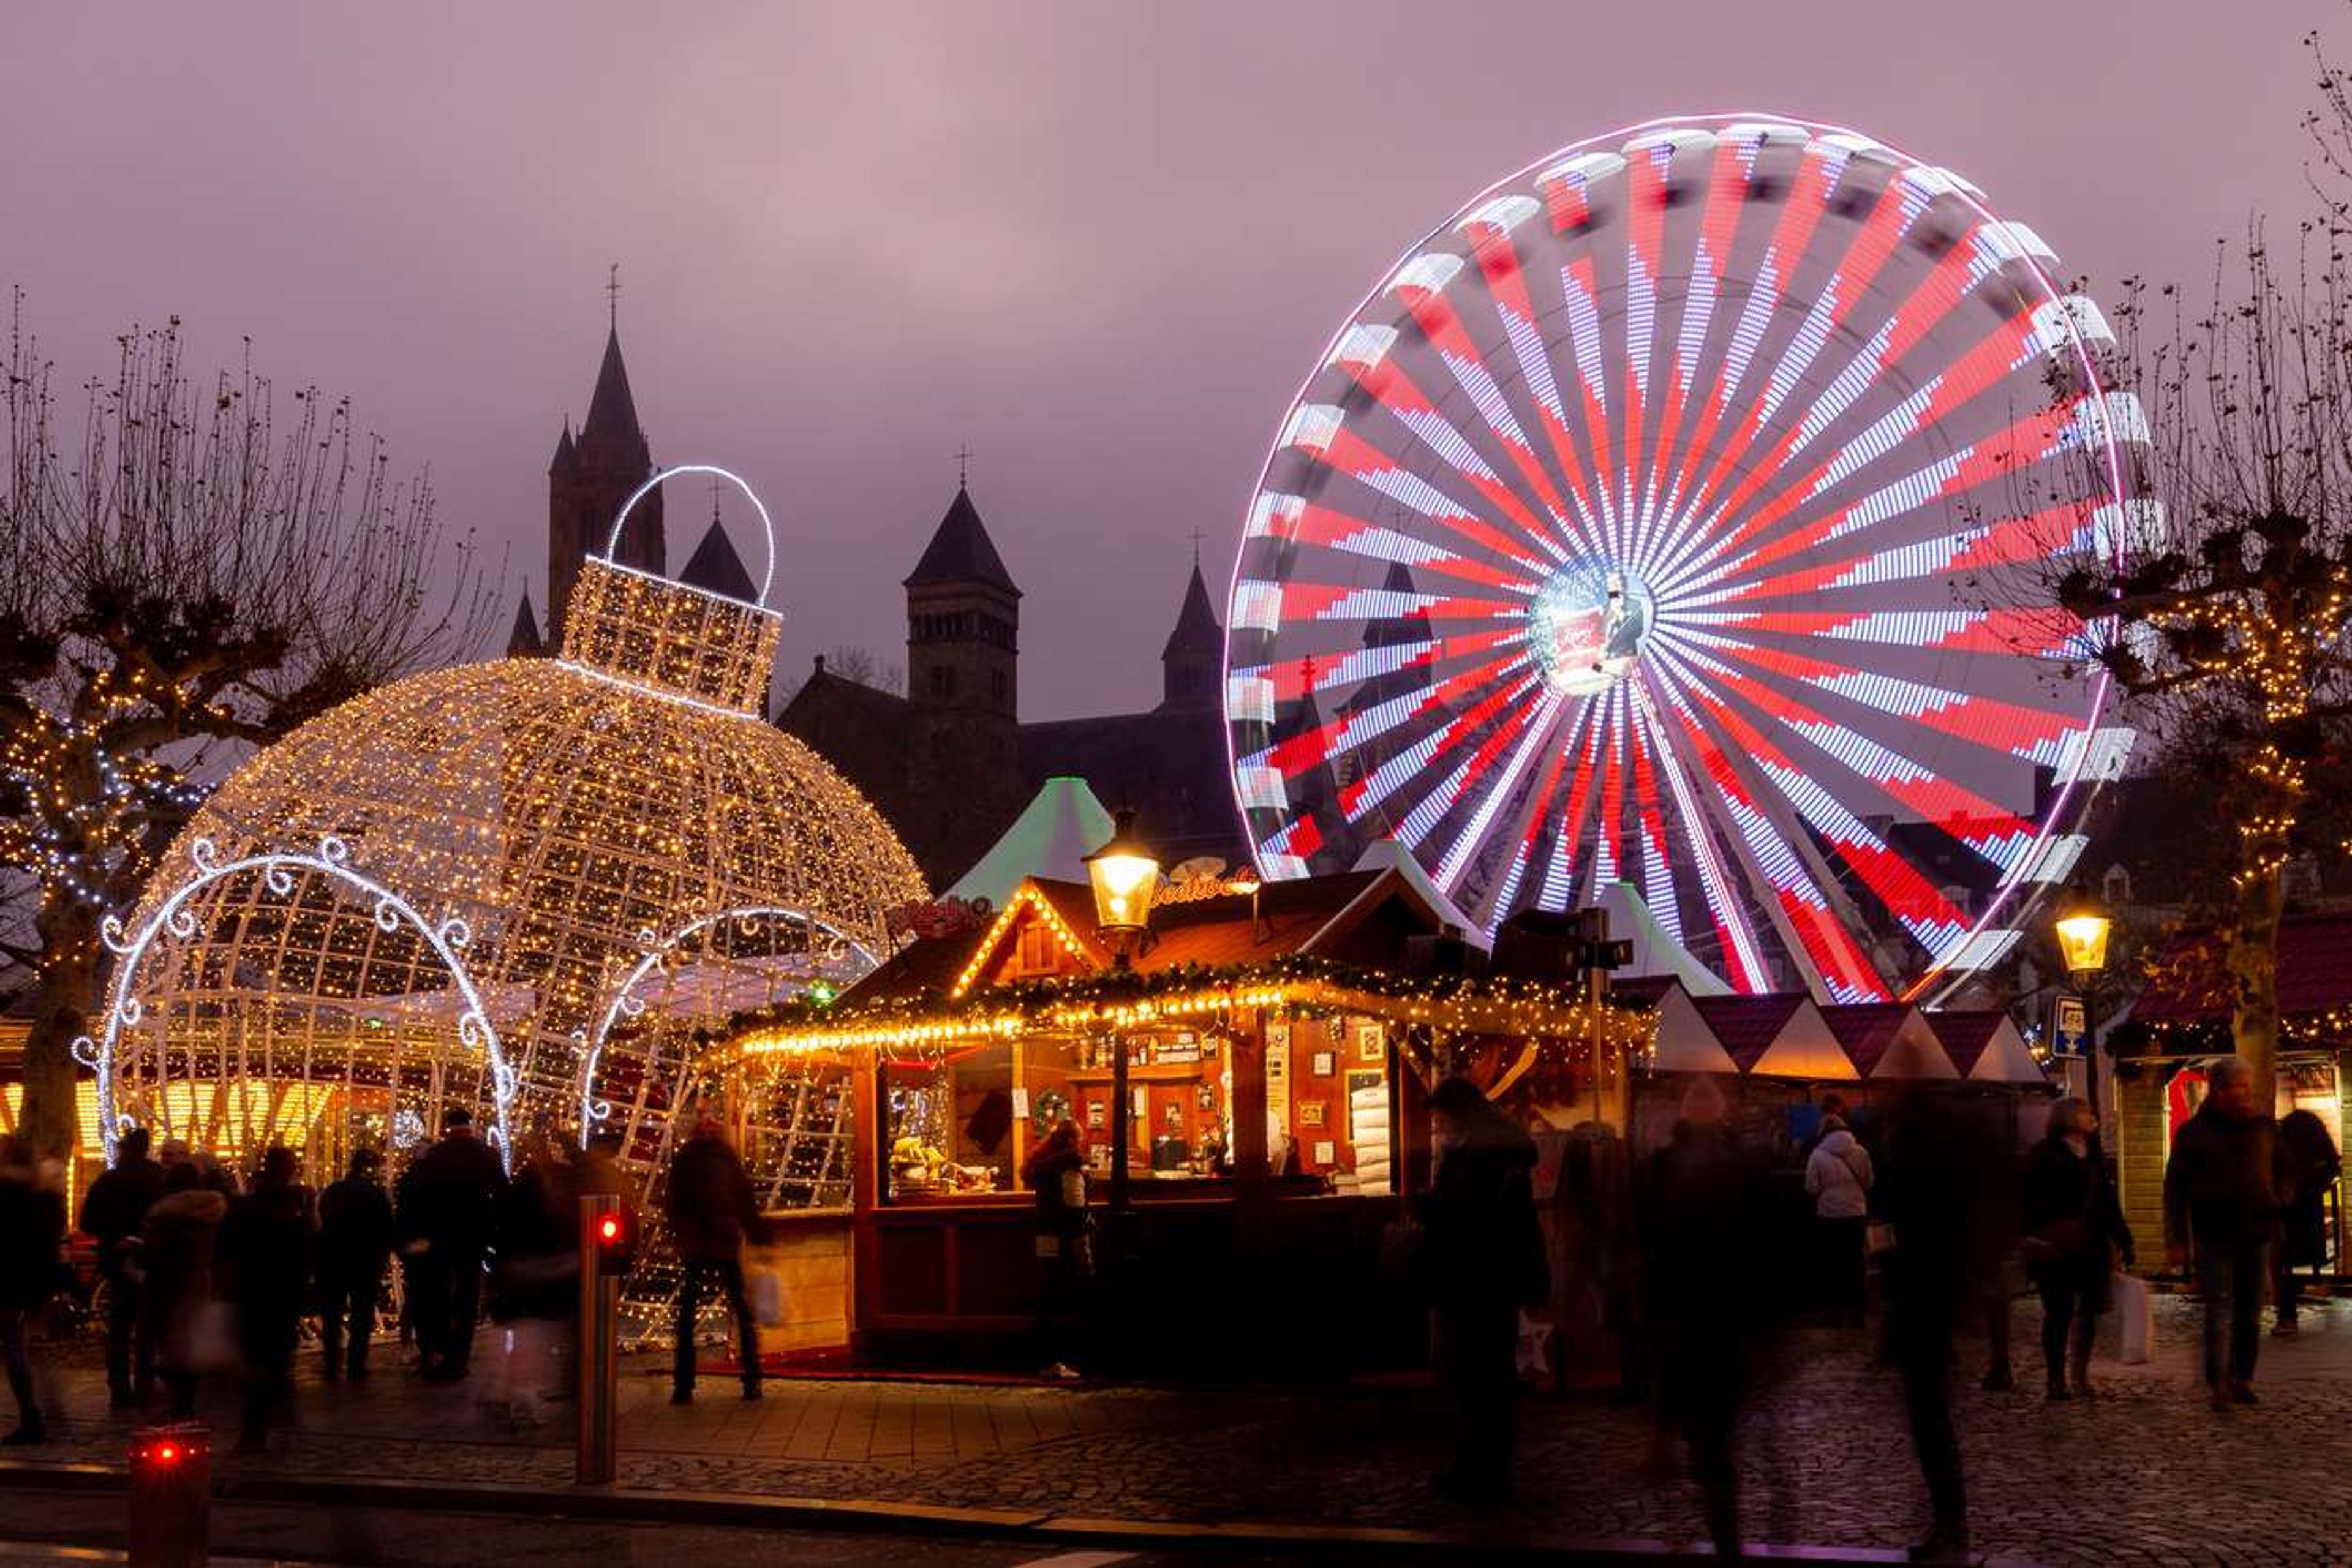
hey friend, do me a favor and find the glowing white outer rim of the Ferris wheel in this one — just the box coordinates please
[1223,110,2131,999]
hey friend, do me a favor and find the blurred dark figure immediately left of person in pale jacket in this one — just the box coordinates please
[1639,1077,1768,1556]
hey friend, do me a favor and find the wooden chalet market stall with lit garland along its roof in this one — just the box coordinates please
[725,870,1646,1375]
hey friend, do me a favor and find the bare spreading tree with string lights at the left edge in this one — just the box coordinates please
[0,294,494,1154]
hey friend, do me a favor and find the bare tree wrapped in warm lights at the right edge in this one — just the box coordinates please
[2049,239,2352,1100]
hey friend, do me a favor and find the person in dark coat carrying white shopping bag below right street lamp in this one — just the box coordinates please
[2025,1098,2131,1399]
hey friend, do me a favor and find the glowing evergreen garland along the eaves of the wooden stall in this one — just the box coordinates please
[729,952,1651,1055]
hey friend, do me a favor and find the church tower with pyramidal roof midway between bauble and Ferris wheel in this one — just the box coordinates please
[901,484,1025,881]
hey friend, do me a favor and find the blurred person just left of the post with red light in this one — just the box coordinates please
[487,1131,581,1430]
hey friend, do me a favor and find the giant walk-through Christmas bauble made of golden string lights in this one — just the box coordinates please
[99,466,924,1169]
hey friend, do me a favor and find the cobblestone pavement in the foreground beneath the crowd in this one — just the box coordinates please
[26,1298,2352,1563]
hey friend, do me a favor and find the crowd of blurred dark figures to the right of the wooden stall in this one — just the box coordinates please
[1420,1060,2340,1561]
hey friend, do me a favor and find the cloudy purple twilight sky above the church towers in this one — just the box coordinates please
[0,0,2352,717]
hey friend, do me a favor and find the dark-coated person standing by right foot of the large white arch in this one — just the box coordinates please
[400,1105,506,1382]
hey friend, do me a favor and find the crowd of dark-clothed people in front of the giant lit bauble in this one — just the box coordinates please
[0,1107,762,1453]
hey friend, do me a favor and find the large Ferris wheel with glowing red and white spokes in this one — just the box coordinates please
[1226,115,2162,999]
